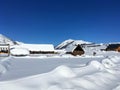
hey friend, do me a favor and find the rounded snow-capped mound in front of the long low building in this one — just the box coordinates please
[10,48,30,56]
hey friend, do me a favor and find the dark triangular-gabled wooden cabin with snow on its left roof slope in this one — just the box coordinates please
[66,44,85,56]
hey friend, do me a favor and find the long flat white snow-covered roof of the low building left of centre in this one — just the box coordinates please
[20,44,54,51]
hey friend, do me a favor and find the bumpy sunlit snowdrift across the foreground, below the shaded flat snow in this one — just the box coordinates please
[0,56,120,90]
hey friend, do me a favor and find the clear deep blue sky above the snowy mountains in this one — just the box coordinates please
[0,0,120,45]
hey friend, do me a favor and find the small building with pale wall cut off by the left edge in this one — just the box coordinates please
[0,44,10,56]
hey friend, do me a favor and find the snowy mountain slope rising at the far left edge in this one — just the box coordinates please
[0,34,17,45]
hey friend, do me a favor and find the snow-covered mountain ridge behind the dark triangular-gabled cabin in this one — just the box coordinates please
[56,39,92,49]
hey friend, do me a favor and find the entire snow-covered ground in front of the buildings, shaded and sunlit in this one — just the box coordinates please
[0,52,120,90]
